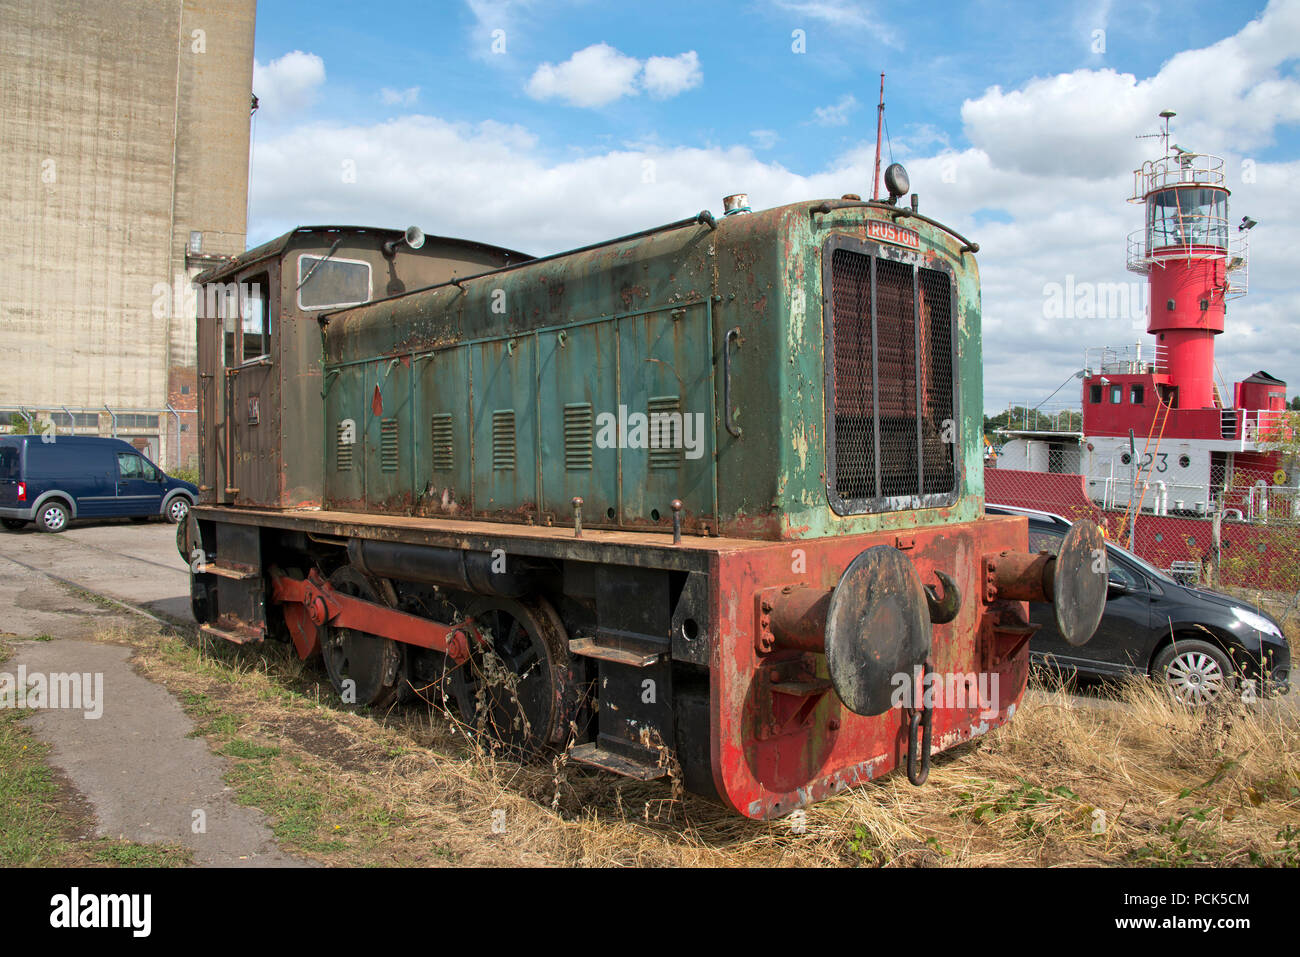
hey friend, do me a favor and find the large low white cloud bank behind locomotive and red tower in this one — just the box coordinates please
[248,3,1300,411]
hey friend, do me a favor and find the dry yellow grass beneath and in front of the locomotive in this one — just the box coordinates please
[104,621,1300,866]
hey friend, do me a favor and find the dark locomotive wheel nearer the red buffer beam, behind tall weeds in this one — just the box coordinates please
[457,597,579,753]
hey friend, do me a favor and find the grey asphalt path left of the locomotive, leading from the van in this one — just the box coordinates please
[0,523,304,867]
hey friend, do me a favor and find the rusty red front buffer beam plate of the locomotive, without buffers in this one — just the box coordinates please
[710,516,1028,818]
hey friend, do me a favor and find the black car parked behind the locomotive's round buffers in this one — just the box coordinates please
[985,506,1291,705]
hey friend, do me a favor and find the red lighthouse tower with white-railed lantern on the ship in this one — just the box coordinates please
[1128,111,1247,410]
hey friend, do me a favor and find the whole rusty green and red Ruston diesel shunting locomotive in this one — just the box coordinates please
[178,166,1106,818]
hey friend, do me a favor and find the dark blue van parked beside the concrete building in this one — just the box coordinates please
[0,436,199,532]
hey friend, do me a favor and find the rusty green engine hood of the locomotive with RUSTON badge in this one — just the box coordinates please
[322,203,983,540]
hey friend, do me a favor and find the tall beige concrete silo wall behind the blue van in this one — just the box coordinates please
[0,0,256,460]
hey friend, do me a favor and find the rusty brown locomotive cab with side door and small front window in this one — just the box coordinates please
[195,226,529,508]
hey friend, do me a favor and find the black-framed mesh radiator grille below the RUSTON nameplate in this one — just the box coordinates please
[828,248,957,511]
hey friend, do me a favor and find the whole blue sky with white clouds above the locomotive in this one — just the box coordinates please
[248,0,1300,410]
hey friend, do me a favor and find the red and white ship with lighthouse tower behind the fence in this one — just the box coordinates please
[988,112,1300,579]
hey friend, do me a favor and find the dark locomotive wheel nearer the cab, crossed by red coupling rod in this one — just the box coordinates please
[321,566,406,707]
